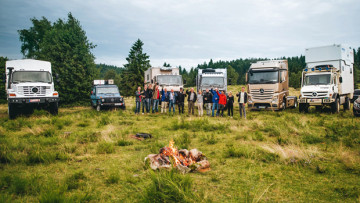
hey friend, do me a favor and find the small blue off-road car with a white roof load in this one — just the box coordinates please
[90,80,126,111]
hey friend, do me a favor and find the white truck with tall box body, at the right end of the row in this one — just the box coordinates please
[299,44,354,113]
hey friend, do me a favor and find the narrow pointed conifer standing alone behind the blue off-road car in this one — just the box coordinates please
[120,39,151,96]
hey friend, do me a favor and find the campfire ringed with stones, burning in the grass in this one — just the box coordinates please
[145,140,210,173]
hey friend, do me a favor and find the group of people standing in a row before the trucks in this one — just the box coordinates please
[135,84,247,118]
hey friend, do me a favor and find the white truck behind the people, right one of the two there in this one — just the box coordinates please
[196,69,227,92]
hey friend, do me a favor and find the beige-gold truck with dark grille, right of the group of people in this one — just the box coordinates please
[246,60,297,110]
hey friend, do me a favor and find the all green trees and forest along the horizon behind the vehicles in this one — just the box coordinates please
[0,13,360,105]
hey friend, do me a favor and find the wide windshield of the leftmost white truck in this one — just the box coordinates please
[12,71,52,83]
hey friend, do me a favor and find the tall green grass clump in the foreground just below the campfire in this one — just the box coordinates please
[143,170,198,202]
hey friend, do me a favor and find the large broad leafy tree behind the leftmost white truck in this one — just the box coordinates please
[18,13,98,104]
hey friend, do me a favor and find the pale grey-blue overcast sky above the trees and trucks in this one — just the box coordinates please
[0,0,360,68]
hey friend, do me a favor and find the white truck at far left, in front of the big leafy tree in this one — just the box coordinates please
[5,59,59,119]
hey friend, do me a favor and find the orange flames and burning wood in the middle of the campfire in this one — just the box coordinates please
[160,140,195,166]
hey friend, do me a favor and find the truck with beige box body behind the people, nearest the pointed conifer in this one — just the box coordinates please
[144,67,184,92]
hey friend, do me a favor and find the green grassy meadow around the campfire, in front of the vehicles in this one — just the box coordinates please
[0,87,360,202]
